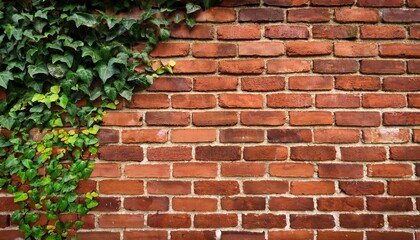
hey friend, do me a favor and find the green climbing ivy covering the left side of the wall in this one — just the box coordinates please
[0,0,217,239]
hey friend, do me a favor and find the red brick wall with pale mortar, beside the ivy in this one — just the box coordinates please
[0,0,420,240]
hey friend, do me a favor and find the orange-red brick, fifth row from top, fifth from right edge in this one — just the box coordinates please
[219,59,265,74]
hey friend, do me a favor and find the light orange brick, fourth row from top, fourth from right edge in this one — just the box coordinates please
[238,42,284,57]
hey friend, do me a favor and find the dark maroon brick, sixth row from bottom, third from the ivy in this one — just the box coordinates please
[195,146,241,161]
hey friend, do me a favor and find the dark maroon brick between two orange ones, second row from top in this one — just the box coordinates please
[239,8,284,22]
